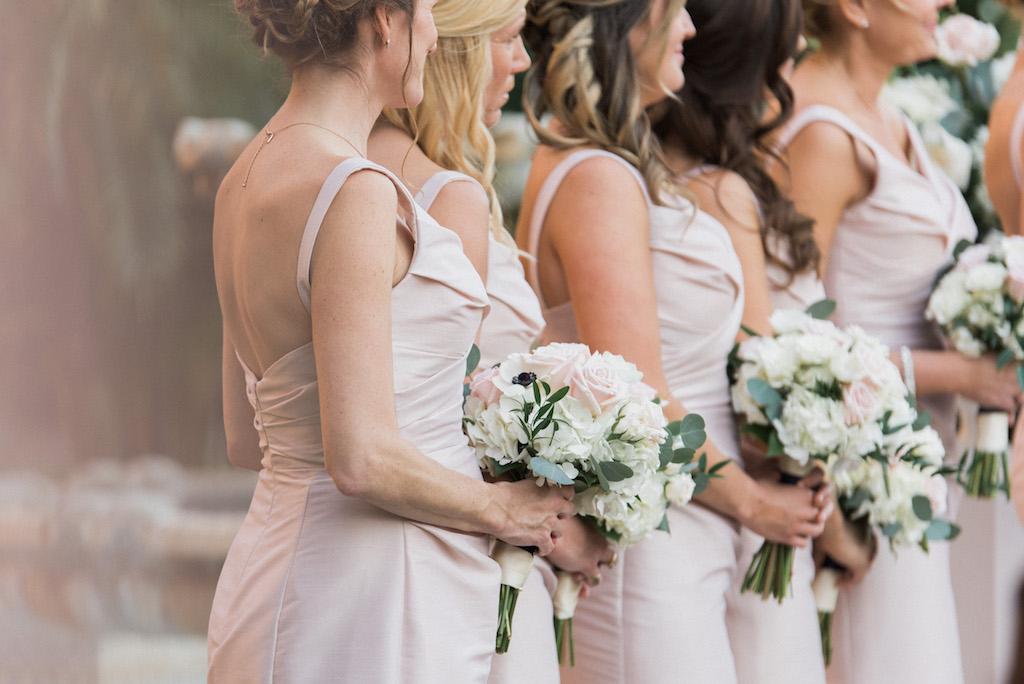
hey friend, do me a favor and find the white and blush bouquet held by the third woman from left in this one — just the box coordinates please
[731,300,950,602]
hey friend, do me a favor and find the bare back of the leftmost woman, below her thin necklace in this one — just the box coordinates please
[213,129,413,376]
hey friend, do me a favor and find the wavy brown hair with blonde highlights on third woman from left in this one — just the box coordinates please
[523,0,692,204]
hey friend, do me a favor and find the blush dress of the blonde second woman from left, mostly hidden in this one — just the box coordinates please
[416,171,558,684]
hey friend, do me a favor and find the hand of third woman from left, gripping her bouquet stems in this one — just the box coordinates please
[739,472,833,548]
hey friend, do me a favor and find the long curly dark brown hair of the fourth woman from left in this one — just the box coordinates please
[654,0,820,276]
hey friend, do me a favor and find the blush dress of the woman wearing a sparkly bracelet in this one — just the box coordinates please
[780,105,977,684]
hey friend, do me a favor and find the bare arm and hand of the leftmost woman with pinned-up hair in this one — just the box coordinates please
[310,166,572,554]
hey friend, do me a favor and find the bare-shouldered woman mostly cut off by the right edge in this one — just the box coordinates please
[985,0,1024,236]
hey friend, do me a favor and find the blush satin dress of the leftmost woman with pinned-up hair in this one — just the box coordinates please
[209,158,501,684]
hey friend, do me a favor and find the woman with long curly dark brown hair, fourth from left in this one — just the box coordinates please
[654,0,871,682]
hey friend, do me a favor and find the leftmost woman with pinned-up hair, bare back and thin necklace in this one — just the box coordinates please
[209,0,572,683]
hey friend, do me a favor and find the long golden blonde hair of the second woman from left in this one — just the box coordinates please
[384,0,526,247]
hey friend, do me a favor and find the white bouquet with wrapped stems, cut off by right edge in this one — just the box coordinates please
[925,232,1024,499]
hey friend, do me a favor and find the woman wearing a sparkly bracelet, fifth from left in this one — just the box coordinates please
[780,0,1019,684]
